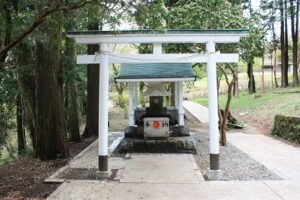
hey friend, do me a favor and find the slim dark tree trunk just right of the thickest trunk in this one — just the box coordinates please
[65,16,81,142]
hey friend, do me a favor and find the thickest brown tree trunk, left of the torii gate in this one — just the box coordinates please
[36,13,69,160]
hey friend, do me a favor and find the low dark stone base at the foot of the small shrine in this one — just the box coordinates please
[115,136,196,154]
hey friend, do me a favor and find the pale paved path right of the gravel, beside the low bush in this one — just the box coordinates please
[228,133,300,181]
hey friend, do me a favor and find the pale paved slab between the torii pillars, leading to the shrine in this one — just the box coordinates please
[120,153,204,184]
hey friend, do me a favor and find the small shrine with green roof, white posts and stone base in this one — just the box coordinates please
[115,63,196,153]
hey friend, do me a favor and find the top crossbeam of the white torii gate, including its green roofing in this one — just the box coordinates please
[68,29,249,44]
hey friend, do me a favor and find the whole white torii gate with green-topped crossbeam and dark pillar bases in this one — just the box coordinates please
[68,29,249,179]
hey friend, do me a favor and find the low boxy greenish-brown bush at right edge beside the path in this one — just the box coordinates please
[272,115,300,143]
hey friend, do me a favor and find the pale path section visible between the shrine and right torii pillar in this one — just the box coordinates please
[183,101,209,123]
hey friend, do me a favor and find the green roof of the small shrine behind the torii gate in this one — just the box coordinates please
[116,63,195,80]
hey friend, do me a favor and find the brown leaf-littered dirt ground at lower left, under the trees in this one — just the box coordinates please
[0,137,96,199]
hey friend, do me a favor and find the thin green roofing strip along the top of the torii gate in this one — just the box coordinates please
[68,29,249,35]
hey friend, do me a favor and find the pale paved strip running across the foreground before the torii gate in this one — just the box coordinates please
[48,181,300,200]
